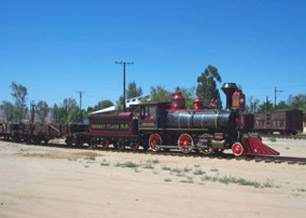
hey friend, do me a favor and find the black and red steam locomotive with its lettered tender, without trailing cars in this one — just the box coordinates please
[85,83,278,156]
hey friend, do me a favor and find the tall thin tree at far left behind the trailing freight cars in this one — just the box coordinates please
[11,82,28,123]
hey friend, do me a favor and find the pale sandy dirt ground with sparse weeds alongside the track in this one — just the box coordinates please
[0,139,306,218]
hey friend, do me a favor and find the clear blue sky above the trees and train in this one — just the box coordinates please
[0,0,306,108]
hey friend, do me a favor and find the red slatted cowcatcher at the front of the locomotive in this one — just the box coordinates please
[241,137,279,155]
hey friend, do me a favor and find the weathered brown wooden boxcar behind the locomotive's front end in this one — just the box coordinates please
[241,110,303,135]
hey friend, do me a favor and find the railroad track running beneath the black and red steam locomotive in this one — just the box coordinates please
[2,140,306,165]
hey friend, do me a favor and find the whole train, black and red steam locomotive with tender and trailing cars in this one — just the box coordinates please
[0,83,279,156]
